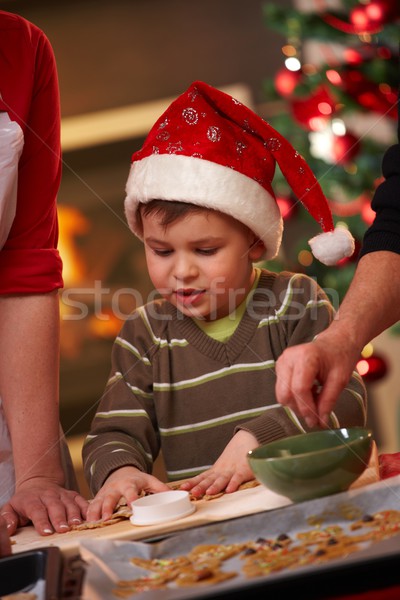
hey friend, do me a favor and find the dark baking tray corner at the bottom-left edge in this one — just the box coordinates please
[0,546,62,600]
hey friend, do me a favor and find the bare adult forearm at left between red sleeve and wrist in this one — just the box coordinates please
[0,292,64,487]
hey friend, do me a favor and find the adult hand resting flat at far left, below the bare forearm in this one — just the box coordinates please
[0,478,88,535]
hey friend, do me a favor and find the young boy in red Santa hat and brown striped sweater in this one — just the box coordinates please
[83,82,366,520]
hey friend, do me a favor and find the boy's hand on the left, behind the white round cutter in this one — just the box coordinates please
[87,467,170,521]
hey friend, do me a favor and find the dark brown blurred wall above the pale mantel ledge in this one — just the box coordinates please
[0,0,290,116]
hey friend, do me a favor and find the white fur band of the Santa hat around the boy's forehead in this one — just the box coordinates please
[125,154,283,260]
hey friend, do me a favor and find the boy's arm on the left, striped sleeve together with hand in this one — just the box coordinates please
[82,319,170,521]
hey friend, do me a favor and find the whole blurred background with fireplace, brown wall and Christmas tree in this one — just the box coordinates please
[0,0,400,490]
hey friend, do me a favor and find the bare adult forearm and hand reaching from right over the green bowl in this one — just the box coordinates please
[275,251,400,427]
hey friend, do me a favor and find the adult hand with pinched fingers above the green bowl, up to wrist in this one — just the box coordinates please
[275,332,359,427]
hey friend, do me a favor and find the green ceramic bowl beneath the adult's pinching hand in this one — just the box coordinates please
[247,427,373,502]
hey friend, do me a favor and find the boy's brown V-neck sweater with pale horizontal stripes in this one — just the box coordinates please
[83,270,366,494]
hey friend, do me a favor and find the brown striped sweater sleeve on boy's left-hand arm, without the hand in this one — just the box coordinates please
[82,319,160,495]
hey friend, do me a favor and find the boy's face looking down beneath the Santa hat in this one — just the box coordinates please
[142,209,264,321]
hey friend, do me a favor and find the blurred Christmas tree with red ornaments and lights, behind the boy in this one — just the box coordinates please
[264,0,400,300]
